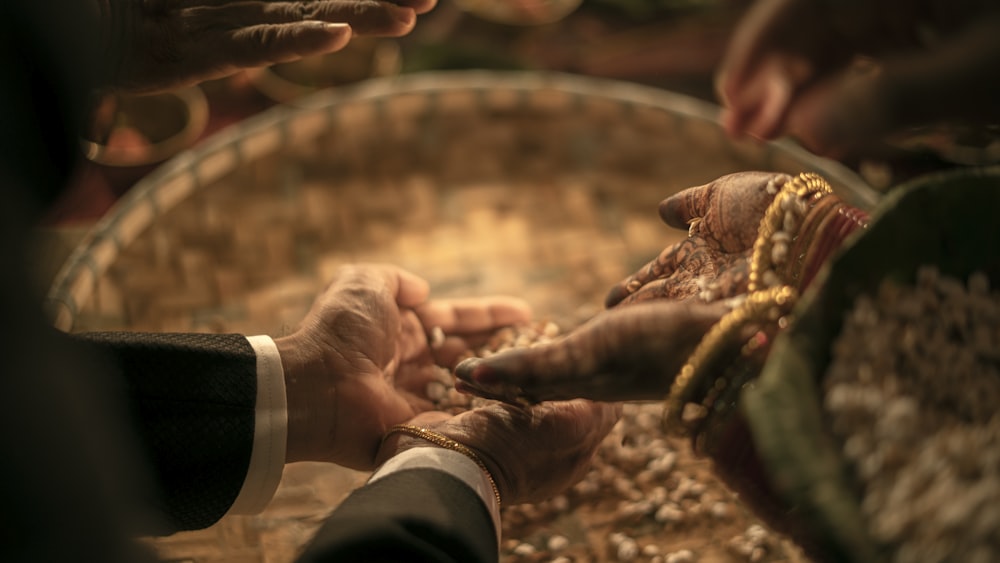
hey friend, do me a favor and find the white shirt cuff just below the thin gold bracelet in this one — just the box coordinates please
[368,447,500,545]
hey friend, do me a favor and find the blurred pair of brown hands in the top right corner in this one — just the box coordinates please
[716,0,1000,157]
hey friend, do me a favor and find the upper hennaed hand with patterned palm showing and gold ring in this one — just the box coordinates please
[605,172,791,307]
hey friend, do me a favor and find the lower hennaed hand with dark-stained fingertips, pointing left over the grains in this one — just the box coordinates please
[455,301,727,402]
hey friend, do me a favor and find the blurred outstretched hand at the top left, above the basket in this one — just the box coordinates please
[92,0,437,92]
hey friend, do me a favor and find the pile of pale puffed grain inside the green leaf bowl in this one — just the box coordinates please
[824,267,1000,563]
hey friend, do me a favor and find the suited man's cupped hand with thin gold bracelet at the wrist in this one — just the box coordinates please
[378,400,621,506]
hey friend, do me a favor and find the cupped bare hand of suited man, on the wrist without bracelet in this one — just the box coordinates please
[275,265,531,469]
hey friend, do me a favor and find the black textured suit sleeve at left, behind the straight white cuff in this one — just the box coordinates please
[77,332,257,533]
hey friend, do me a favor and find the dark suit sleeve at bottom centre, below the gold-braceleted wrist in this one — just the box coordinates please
[299,469,498,563]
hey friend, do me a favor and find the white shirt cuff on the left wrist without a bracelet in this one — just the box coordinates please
[226,336,288,515]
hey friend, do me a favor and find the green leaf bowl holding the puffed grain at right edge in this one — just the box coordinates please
[741,167,1000,561]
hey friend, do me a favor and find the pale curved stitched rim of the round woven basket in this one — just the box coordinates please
[44,70,881,332]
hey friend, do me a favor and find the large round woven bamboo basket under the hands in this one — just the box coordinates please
[47,72,877,561]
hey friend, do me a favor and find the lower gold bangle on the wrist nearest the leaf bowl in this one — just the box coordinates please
[664,285,799,434]
